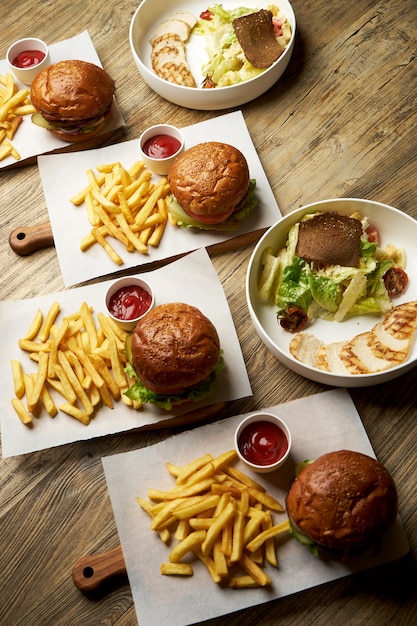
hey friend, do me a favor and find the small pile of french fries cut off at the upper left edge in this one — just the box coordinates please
[0,73,35,161]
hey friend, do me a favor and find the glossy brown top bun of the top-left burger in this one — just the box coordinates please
[30,60,115,121]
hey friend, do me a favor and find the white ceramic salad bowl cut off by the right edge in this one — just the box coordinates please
[246,198,417,387]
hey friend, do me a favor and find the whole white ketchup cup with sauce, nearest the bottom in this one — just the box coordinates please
[235,412,291,474]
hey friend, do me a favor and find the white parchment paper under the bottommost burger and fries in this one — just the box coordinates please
[103,389,408,626]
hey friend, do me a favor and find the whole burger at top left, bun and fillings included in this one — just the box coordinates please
[30,60,115,143]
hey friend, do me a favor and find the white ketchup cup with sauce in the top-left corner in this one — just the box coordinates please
[6,37,51,85]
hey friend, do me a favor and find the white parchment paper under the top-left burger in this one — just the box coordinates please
[0,30,125,168]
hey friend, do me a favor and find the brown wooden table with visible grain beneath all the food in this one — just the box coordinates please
[0,0,417,626]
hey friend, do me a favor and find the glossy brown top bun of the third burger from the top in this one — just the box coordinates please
[131,302,220,394]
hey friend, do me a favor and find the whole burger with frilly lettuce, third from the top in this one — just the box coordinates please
[126,302,224,410]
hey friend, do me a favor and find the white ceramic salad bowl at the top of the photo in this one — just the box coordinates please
[129,0,296,111]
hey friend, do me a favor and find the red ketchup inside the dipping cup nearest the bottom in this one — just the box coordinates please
[238,420,288,466]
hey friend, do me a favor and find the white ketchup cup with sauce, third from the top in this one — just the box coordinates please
[106,276,155,330]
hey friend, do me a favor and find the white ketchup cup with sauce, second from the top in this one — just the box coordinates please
[139,124,184,176]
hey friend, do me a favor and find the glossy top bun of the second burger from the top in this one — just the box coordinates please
[168,141,250,219]
